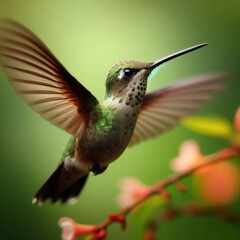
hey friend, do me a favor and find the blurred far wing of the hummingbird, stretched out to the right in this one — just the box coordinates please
[129,73,227,146]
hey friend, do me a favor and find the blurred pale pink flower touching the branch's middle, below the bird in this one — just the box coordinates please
[117,177,151,208]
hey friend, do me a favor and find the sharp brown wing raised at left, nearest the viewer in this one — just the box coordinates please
[0,20,98,137]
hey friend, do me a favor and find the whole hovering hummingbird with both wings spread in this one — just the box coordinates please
[0,19,225,203]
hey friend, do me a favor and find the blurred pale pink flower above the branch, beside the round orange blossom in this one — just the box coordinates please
[171,140,205,172]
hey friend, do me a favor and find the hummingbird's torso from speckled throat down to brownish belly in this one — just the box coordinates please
[78,75,147,166]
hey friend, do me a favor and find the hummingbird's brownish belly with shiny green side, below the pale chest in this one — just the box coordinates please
[77,106,139,169]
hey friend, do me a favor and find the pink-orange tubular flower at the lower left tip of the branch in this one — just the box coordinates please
[58,218,99,240]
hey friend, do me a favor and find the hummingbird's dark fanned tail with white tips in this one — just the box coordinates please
[33,162,88,204]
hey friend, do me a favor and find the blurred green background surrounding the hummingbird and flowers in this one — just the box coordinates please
[0,0,240,240]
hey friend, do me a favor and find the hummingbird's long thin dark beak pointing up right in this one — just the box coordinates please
[148,43,208,69]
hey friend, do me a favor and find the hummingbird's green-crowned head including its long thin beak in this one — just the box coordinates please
[106,43,207,105]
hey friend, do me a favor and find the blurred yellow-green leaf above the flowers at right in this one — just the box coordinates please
[181,117,232,140]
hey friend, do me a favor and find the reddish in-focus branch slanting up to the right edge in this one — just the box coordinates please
[60,147,240,240]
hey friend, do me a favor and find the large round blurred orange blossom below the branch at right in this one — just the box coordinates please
[198,162,240,206]
